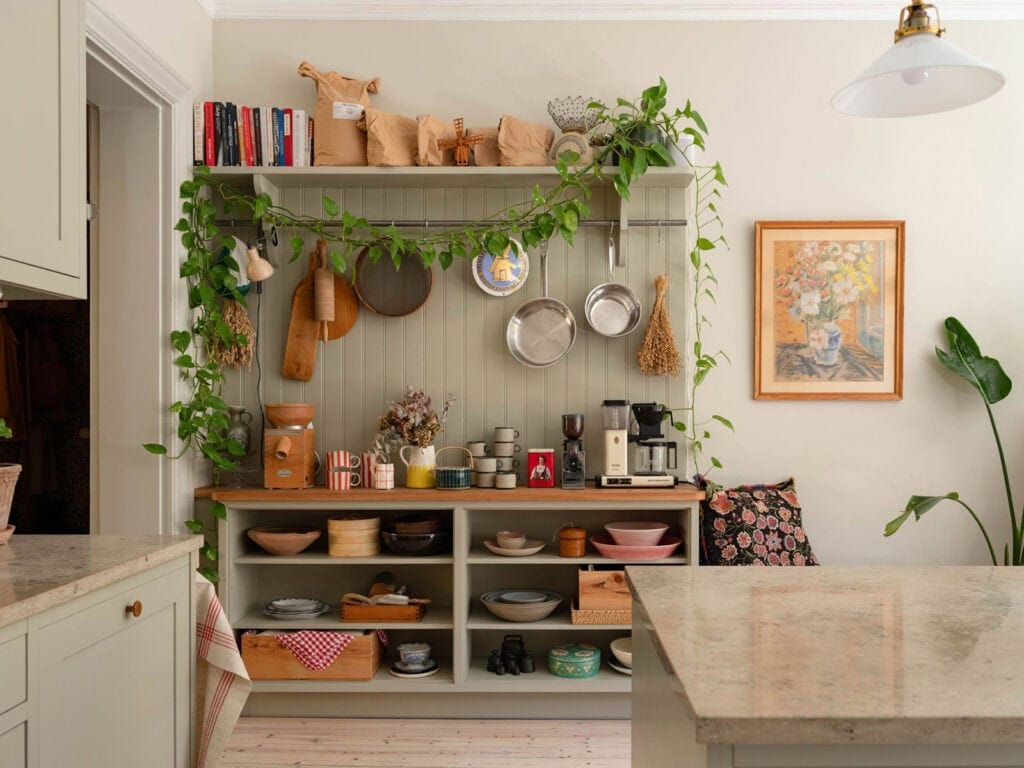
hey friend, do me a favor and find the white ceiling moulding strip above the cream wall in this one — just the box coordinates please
[197,0,1024,25]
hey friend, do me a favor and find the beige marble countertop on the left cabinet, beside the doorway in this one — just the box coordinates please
[0,535,203,627]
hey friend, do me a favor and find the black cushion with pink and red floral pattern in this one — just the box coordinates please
[700,478,818,565]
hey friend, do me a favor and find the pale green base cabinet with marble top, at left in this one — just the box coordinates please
[0,536,203,768]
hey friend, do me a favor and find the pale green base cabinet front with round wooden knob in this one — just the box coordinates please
[37,568,191,768]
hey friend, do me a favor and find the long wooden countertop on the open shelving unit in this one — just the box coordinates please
[196,483,705,505]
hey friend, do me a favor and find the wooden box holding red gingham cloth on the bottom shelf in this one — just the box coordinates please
[242,630,382,680]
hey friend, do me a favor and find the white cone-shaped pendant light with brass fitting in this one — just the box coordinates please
[831,0,1006,118]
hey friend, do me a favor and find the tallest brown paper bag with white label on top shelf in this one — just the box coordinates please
[299,61,380,166]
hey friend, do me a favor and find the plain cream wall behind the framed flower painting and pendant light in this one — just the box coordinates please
[213,20,1024,564]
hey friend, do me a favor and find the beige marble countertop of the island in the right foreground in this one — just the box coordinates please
[627,566,1024,744]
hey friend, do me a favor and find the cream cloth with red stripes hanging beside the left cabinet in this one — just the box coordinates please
[194,573,252,768]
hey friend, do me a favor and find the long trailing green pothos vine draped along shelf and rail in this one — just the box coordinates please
[144,79,732,581]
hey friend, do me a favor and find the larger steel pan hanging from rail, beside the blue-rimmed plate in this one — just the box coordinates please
[505,241,575,368]
